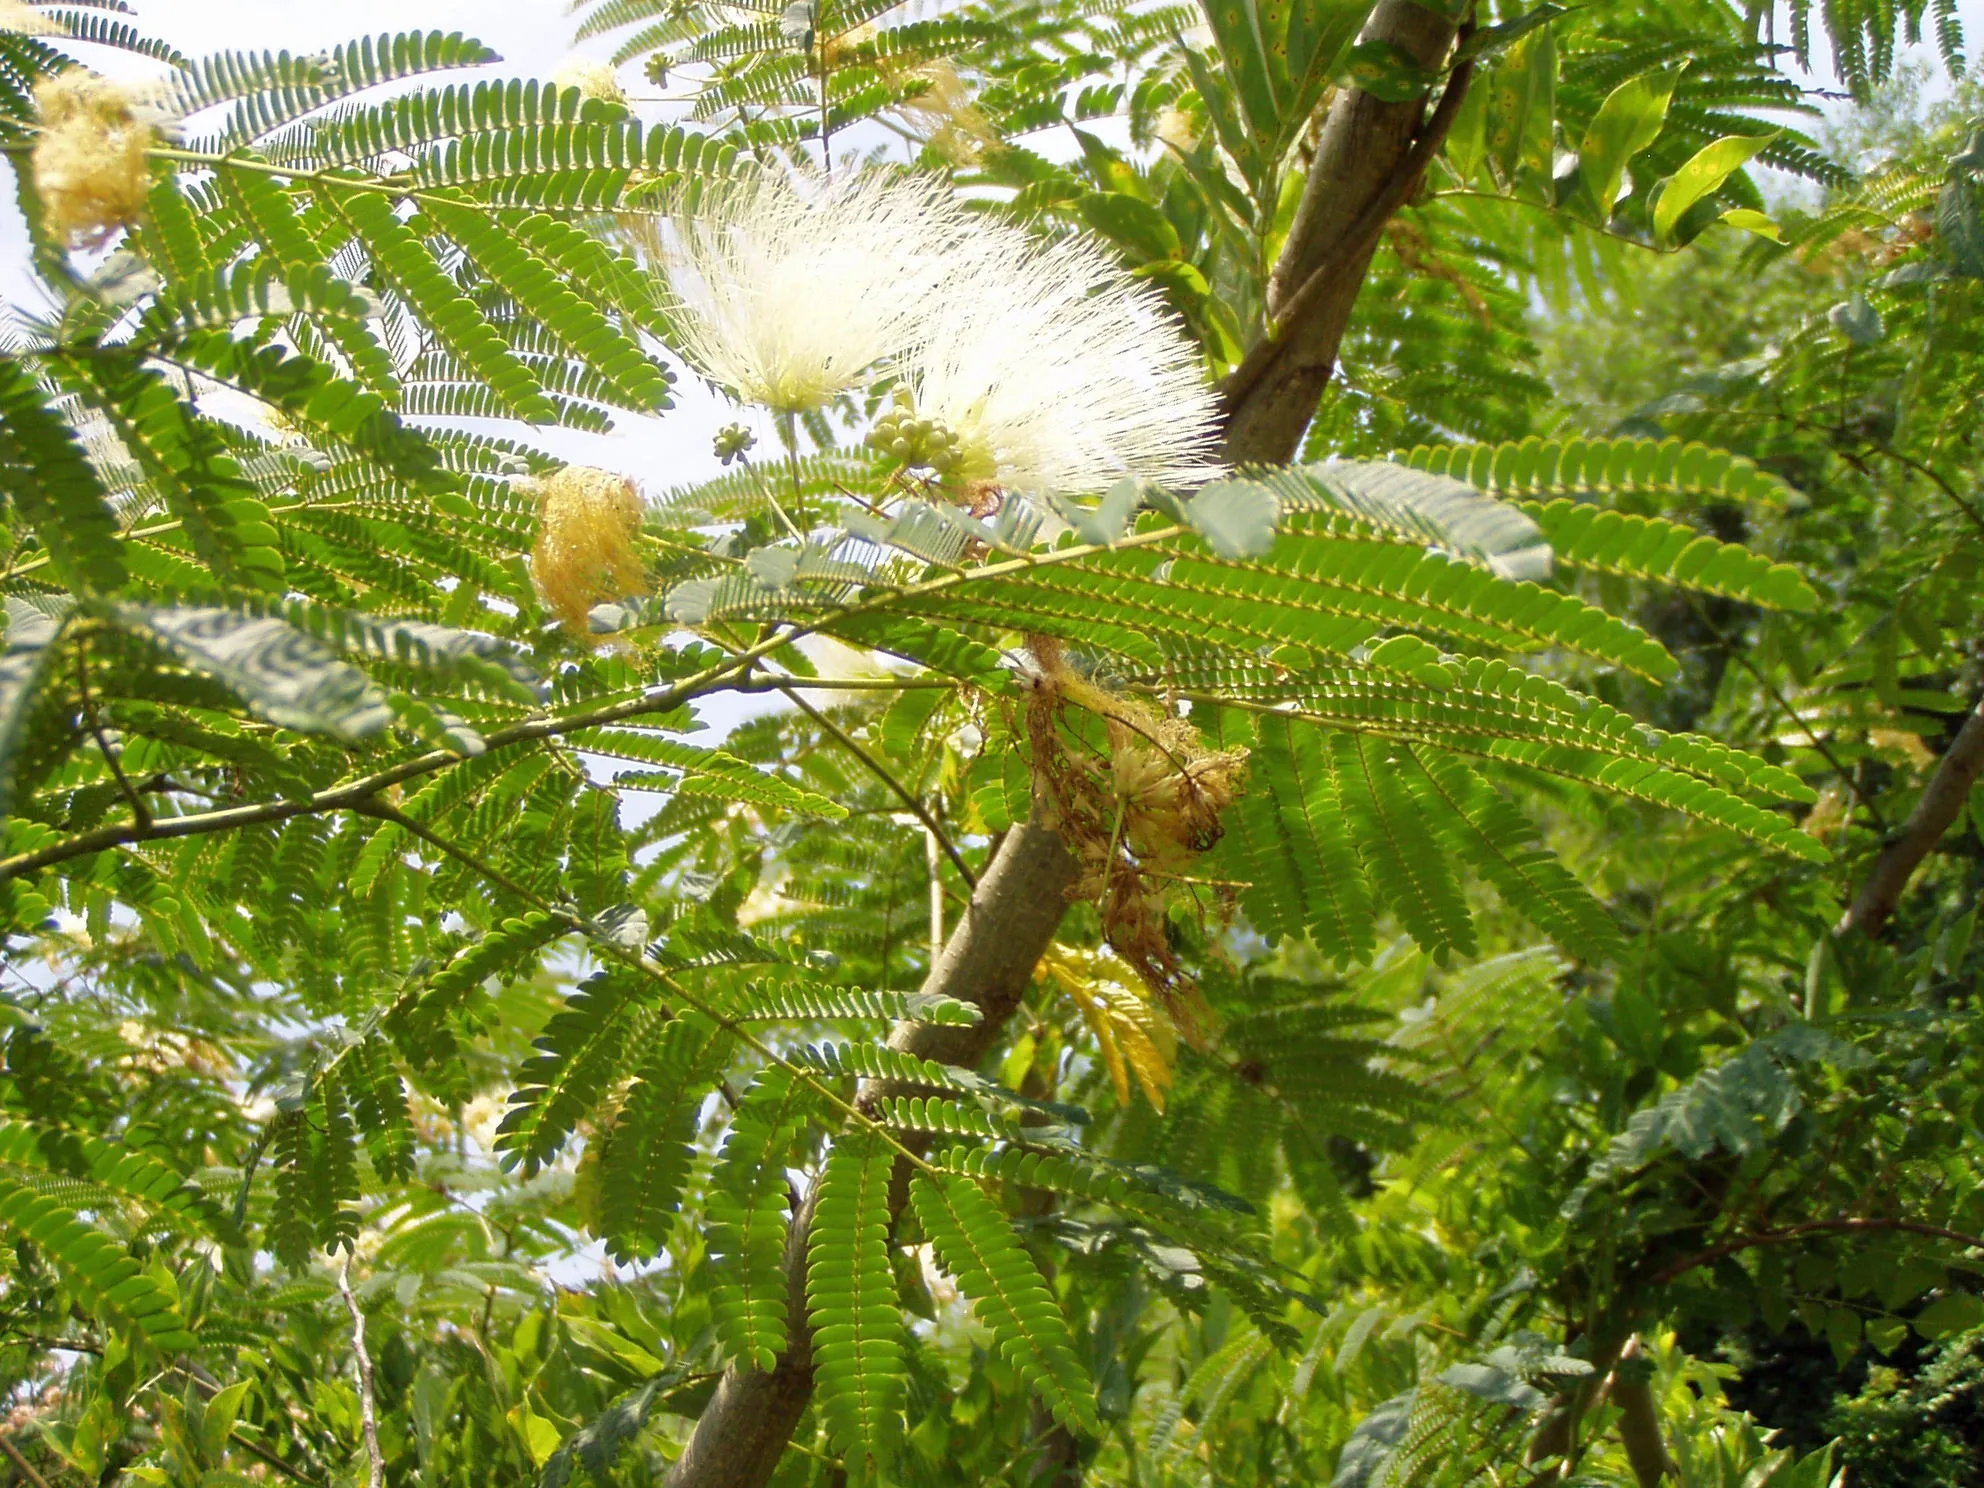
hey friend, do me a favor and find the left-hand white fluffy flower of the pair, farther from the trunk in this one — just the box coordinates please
[642,171,970,413]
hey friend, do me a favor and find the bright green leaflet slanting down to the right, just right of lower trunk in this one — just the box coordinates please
[909,1173,1101,1434]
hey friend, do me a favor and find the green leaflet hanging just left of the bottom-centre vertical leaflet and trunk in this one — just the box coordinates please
[706,1065,813,1371]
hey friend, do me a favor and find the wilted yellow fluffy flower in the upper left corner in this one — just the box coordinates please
[34,67,153,248]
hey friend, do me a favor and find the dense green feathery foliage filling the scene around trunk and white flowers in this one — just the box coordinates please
[0,0,1984,1488]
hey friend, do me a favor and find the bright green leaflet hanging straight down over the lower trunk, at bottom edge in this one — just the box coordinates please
[806,1133,909,1482]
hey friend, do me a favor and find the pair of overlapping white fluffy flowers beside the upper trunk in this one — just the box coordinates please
[642,171,1216,492]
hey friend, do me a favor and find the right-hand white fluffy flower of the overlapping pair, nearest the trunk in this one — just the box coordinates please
[897,226,1218,492]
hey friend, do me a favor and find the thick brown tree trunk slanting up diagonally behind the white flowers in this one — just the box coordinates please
[667,0,1466,1488]
